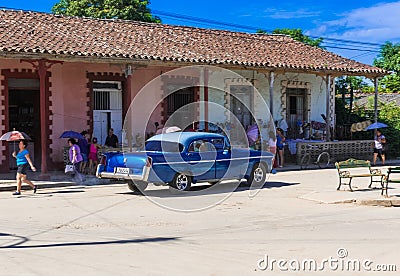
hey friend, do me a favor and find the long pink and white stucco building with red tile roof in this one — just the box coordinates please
[0,10,386,176]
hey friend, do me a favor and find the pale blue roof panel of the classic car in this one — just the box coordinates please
[147,132,225,145]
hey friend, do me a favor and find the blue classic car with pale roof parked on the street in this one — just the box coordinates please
[96,132,273,192]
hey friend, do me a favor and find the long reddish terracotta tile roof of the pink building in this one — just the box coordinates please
[0,10,386,75]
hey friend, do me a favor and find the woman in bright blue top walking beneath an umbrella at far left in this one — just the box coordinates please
[13,140,36,195]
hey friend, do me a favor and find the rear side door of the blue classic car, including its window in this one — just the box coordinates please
[186,138,217,181]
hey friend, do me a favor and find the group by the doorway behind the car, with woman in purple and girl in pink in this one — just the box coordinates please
[68,128,118,182]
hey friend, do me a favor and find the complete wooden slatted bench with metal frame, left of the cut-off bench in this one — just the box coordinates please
[335,158,386,194]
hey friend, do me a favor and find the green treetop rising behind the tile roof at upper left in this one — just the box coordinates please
[52,0,161,23]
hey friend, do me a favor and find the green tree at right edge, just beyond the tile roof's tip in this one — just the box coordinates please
[374,42,400,92]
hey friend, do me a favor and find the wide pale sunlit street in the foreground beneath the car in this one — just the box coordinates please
[0,169,400,275]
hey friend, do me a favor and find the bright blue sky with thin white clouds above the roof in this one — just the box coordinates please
[0,0,400,64]
